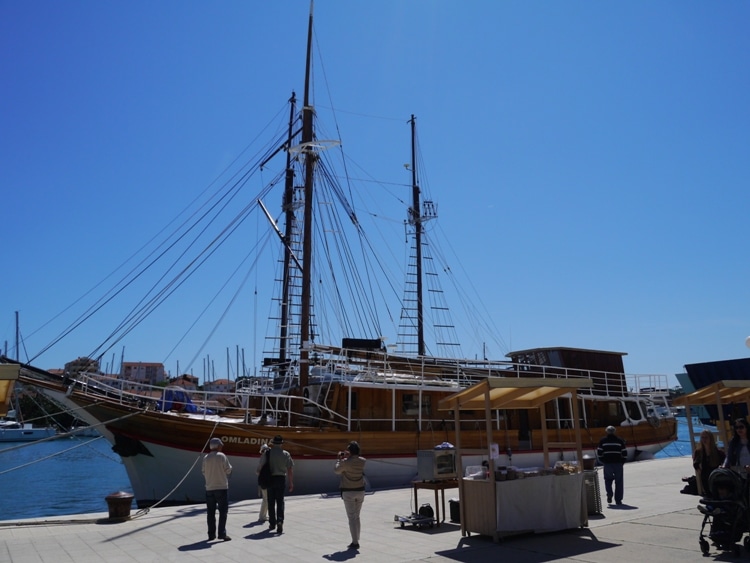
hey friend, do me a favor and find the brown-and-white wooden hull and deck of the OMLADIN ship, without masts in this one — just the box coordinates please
[4,349,676,506]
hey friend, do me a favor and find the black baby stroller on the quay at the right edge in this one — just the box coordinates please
[698,468,750,556]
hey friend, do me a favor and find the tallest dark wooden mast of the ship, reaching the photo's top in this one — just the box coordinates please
[299,2,315,388]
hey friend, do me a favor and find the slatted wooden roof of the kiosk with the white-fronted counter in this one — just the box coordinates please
[438,377,594,411]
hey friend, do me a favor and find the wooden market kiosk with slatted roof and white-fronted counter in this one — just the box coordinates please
[439,377,593,541]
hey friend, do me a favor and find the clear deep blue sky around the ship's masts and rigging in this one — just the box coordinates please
[0,0,750,388]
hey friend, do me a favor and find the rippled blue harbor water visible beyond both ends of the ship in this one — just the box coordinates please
[0,419,699,520]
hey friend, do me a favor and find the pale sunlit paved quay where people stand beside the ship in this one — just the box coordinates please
[0,457,728,563]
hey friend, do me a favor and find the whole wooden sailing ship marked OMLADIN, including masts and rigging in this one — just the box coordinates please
[0,5,676,506]
